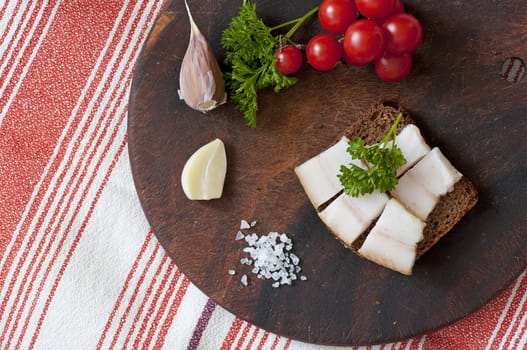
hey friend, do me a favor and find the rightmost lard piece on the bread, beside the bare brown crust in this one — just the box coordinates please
[391,147,462,221]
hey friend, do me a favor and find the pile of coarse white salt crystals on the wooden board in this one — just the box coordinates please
[234,220,307,288]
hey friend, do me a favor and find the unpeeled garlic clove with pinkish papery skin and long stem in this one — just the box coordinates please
[178,0,227,113]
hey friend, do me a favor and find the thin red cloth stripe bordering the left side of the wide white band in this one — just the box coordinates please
[27,136,128,347]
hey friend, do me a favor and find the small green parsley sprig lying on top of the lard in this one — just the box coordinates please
[337,114,406,197]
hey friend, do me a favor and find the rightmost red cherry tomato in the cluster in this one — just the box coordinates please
[382,13,423,54]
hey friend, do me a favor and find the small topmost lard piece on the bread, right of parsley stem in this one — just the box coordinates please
[395,124,430,176]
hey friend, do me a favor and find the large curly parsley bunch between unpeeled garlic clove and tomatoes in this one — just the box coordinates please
[221,0,318,128]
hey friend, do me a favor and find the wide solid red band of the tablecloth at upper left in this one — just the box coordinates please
[0,0,124,260]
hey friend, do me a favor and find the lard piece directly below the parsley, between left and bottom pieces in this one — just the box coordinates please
[318,191,389,245]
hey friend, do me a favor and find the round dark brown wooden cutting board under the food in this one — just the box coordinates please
[129,0,527,345]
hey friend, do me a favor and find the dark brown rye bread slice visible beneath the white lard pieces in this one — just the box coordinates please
[335,103,478,259]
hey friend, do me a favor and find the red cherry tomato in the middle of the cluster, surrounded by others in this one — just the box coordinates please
[343,19,385,65]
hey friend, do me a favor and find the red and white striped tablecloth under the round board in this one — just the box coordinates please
[0,0,527,350]
